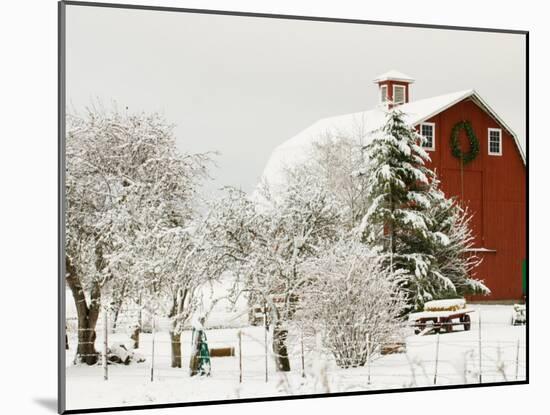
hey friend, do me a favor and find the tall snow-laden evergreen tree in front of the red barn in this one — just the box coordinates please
[359,106,488,309]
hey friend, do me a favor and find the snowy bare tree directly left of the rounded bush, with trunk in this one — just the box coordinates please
[208,171,341,371]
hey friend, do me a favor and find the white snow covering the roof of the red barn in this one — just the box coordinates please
[262,89,525,191]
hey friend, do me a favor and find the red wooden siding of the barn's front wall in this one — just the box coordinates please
[420,99,526,300]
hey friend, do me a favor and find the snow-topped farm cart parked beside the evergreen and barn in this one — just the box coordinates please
[409,308,474,334]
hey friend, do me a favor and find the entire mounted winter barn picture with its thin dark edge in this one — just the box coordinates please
[59,1,529,413]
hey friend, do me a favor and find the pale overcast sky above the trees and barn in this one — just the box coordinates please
[66,5,526,191]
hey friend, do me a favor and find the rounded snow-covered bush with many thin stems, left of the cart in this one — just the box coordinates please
[298,238,405,368]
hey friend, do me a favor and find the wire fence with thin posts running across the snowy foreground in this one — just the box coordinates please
[67,310,527,390]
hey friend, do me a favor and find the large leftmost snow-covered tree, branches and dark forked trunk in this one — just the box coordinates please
[65,109,209,364]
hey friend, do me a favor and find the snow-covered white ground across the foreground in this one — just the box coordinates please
[66,305,526,409]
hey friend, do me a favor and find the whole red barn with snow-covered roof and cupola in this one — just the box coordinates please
[263,71,527,301]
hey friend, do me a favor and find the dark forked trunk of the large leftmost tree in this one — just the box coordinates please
[65,256,101,365]
